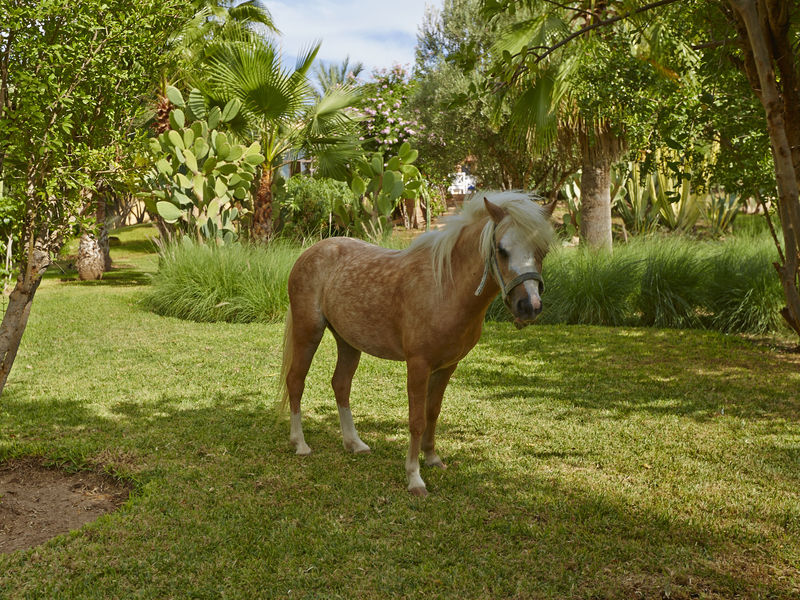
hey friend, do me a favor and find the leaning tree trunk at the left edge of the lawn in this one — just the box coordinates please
[0,249,50,394]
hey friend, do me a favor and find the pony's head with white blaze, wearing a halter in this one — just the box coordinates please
[475,192,554,329]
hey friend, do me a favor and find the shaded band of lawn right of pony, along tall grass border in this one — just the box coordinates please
[451,326,800,421]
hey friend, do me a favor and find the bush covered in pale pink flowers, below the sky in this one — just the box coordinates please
[361,65,422,155]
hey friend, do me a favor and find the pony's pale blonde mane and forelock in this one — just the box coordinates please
[408,191,554,290]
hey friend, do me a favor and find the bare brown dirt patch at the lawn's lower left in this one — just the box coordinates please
[0,459,130,553]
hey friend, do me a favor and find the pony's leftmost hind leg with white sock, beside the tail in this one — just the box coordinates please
[285,314,325,456]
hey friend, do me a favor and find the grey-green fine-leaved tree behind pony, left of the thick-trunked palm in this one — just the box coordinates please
[412,0,578,194]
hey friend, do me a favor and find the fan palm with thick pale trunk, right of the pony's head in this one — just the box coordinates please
[484,0,691,249]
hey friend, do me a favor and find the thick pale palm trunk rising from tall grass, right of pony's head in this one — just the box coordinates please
[580,128,621,250]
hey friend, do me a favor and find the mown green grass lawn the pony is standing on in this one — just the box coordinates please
[0,228,800,599]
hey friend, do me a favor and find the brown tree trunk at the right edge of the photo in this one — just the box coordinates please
[729,0,800,335]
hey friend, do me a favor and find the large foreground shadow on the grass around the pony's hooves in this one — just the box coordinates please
[0,390,798,598]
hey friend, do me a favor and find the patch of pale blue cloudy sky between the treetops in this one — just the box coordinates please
[265,0,442,74]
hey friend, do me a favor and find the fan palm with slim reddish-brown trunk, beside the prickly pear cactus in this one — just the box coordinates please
[201,38,358,240]
